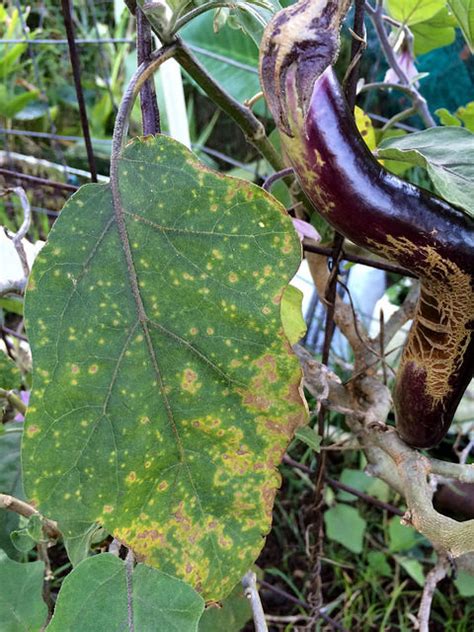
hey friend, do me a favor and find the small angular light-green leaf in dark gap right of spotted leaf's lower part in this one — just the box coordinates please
[324,503,367,553]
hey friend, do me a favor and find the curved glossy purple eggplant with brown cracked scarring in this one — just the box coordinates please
[260,0,474,448]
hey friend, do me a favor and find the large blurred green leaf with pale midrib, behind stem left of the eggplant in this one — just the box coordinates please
[182,14,265,114]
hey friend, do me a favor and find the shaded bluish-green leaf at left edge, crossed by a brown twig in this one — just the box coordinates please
[0,430,25,557]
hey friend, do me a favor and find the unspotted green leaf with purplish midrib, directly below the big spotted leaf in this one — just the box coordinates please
[46,553,204,632]
